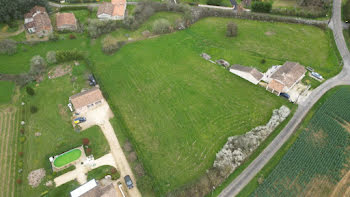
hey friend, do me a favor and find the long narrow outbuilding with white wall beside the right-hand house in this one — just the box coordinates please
[230,64,263,85]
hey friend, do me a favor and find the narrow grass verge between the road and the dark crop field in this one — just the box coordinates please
[238,86,341,197]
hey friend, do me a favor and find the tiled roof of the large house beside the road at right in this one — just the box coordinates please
[271,62,306,88]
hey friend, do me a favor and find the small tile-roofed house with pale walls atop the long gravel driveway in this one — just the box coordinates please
[69,87,105,113]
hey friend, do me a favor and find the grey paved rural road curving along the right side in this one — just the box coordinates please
[219,0,350,197]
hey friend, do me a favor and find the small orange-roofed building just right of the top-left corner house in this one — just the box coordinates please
[56,13,78,31]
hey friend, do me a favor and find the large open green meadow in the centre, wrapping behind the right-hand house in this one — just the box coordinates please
[87,18,337,194]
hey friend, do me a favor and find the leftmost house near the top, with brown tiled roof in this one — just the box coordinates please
[24,6,52,37]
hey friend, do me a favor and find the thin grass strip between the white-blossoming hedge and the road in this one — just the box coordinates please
[207,105,296,196]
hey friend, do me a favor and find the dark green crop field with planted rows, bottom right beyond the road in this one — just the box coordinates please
[239,86,350,196]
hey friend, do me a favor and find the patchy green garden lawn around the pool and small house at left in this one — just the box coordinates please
[16,63,109,196]
